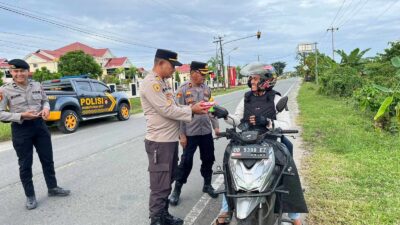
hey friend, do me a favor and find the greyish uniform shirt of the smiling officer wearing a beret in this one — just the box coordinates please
[0,81,50,123]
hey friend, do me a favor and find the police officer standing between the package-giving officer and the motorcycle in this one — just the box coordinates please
[169,61,219,205]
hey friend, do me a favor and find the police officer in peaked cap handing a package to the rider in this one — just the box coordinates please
[140,49,207,225]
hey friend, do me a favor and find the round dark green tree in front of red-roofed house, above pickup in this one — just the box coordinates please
[58,51,103,78]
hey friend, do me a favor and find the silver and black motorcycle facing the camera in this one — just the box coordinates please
[214,97,298,225]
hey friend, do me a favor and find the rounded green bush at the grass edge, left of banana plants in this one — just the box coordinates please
[319,66,363,97]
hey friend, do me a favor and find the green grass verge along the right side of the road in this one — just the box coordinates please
[298,83,400,225]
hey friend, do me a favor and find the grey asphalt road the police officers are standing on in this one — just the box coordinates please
[0,79,299,225]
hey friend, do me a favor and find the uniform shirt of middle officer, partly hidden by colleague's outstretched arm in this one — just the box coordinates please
[176,81,219,136]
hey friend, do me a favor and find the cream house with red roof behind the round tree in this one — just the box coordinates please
[24,42,132,75]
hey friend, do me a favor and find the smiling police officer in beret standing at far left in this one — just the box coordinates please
[0,59,70,209]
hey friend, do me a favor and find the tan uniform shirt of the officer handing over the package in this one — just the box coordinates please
[140,71,192,142]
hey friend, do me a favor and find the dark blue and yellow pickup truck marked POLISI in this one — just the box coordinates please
[42,77,131,133]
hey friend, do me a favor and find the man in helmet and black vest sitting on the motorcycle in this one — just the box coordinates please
[215,62,307,225]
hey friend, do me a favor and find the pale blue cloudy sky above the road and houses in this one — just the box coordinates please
[0,0,400,71]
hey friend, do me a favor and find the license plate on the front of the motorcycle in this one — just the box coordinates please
[231,146,269,159]
